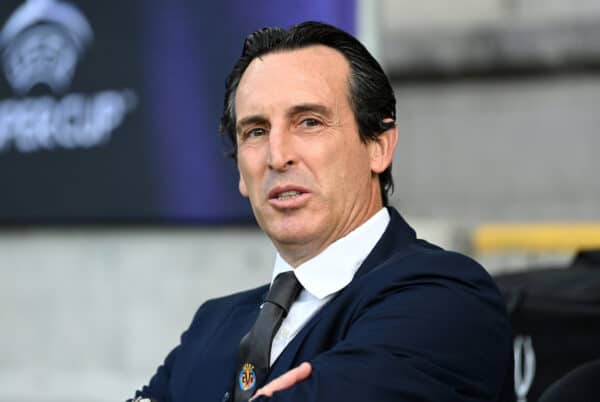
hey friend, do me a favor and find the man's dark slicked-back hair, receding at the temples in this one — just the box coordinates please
[220,22,396,205]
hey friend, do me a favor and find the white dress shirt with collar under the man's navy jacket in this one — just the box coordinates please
[271,208,390,365]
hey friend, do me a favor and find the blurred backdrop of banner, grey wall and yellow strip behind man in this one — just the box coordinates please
[0,0,600,402]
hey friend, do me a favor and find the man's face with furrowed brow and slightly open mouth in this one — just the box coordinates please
[235,46,381,266]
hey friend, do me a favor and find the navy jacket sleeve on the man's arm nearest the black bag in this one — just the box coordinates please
[258,258,514,402]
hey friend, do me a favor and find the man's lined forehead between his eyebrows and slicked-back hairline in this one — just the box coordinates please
[235,45,350,119]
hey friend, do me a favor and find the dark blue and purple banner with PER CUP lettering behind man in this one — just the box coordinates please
[0,0,355,224]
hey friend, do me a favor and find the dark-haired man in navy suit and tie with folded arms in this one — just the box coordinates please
[136,23,514,402]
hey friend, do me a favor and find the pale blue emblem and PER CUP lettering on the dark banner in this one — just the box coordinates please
[0,0,138,153]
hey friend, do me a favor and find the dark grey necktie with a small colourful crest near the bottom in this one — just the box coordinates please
[233,271,302,402]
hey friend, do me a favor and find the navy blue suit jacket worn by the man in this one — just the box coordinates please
[137,208,514,402]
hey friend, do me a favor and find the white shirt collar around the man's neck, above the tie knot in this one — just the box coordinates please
[271,208,390,299]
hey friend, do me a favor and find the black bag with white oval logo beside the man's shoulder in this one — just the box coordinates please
[495,250,600,402]
